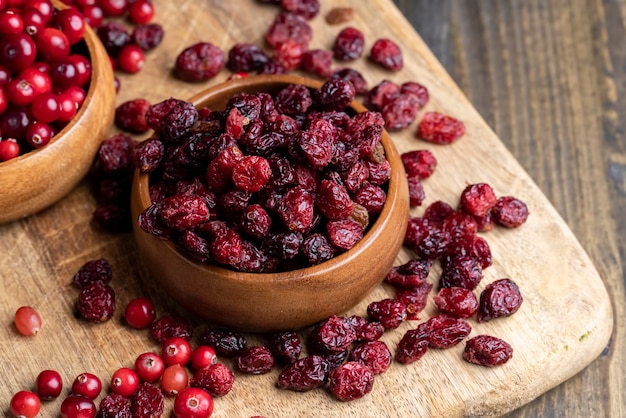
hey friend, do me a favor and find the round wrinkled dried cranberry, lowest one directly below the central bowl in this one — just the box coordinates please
[328,361,374,402]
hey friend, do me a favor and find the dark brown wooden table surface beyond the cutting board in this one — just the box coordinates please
[394,0,626,417]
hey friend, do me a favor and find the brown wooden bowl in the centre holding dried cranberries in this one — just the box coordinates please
[131,76,409,332]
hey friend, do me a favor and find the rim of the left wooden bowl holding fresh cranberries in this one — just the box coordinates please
[0,0,103,169]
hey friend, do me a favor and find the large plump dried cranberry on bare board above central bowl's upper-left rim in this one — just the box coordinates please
[175,42,226,81]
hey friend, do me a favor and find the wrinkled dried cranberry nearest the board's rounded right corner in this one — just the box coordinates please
[477,279,524,322]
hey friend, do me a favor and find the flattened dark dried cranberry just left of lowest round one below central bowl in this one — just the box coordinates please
[278,355,329,392]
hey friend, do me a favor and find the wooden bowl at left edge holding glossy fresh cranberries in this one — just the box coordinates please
[0,2,115,223]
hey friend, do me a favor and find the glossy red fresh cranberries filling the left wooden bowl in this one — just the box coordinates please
[0,0,91,161]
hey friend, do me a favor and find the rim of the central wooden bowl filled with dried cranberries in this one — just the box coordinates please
[132,74,408,284]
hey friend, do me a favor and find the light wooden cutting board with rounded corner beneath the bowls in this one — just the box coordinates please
[0,0,612,417]
